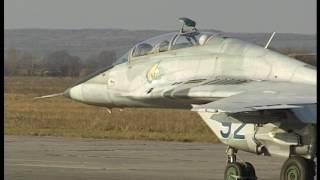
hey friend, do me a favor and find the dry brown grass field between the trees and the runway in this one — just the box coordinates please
[4,77,218,143]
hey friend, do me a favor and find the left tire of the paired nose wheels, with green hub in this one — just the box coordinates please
[224,162,245,180]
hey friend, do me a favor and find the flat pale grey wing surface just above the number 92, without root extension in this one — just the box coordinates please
[193,85,316,113]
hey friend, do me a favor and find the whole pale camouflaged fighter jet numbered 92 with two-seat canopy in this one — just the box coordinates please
[40,18,317,180]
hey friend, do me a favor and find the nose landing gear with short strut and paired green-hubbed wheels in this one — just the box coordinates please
[224,147,257,180]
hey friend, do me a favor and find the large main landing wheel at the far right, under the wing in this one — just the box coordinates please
[280,156,315,180]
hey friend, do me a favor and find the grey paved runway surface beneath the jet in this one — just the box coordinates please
[4,136,285,180]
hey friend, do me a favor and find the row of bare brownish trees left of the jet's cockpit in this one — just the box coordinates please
[4,48,116,77]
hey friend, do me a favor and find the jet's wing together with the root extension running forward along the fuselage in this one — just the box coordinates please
[159,81,317,123]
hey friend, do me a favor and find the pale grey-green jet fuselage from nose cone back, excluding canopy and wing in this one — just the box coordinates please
[64,37,316,109]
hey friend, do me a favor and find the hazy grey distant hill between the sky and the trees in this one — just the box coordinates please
[4,29,316,59]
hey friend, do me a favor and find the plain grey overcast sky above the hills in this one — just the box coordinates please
[4,0,317,34]
